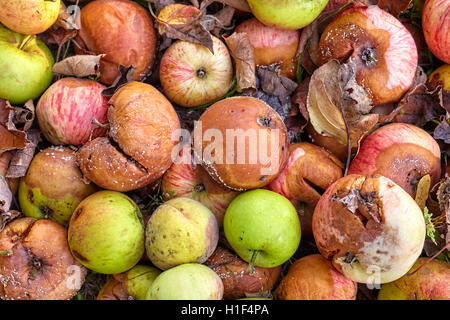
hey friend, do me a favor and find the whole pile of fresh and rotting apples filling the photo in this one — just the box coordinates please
[0,0,450,300]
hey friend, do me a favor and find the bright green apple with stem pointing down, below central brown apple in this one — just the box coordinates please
[223,189,301,268]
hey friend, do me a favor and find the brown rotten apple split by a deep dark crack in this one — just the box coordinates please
[77,82,180,191]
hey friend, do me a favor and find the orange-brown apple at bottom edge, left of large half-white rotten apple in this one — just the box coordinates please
[274,254,357,300]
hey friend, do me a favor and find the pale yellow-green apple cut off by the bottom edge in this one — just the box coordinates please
[147,263,223,300]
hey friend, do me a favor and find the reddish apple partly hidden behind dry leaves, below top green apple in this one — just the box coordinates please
[235,18,300,79]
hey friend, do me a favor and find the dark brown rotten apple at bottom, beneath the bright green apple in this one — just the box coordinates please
[205,246,281,300]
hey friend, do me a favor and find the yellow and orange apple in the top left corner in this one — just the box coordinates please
[0,0,61,34]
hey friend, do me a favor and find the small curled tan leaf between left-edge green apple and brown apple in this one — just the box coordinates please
[53,54,105,78]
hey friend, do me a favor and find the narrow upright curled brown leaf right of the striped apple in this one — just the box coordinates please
[224,32,257,93]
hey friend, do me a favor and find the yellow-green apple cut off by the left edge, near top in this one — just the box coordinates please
[0,25,55,104]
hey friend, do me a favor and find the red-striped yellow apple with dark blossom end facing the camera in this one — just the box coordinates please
[159,36,233,107]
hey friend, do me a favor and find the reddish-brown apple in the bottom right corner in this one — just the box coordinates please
[378,258,450,300]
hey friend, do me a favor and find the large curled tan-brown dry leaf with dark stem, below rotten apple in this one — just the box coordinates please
[307,59,379,148]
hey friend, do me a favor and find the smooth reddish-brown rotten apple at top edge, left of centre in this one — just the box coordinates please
[75,0,157,85]
